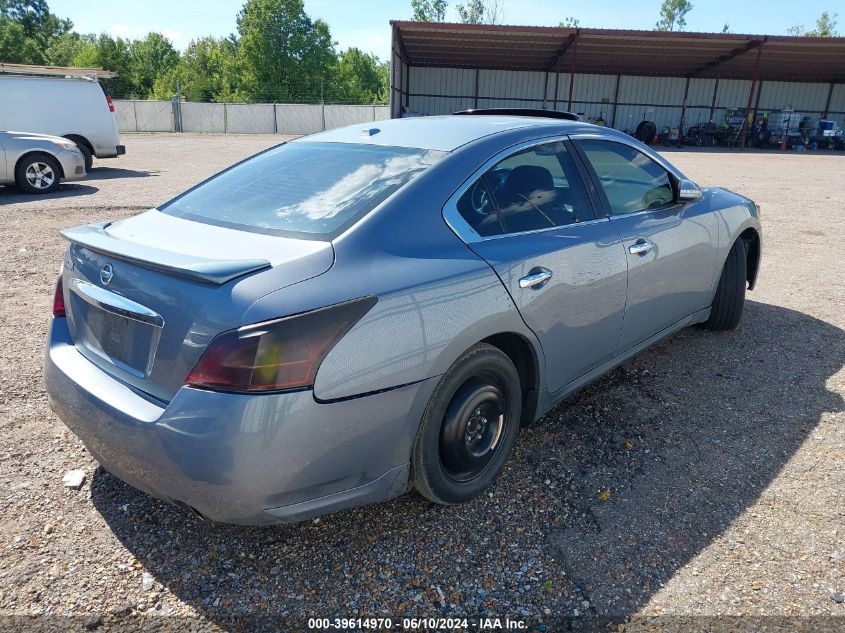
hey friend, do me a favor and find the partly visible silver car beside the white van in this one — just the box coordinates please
[0,131,85,193]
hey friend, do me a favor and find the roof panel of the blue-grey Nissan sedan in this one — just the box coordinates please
[296,114,594,152]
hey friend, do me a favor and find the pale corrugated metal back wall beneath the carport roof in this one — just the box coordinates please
[392,67,845,130]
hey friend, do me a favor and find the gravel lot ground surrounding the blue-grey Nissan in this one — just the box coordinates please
[0,134,845,631]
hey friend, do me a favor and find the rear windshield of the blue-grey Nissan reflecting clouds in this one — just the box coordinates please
[159,142,445,239]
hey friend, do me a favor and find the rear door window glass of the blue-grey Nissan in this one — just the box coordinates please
[458,142,594,237]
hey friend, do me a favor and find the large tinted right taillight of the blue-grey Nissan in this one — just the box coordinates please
[190,297,376,392]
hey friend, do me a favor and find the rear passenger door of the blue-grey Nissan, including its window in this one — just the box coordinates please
[446,140,626,391]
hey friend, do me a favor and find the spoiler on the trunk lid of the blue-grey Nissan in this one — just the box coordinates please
[59,222,270,285]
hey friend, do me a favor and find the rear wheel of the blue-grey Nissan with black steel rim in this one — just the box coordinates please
[411,343,522,504]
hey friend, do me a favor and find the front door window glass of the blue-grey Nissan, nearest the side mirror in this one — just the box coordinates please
[578,140,675,215]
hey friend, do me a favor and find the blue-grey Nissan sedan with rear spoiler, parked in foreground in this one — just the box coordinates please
[44,112,762,524]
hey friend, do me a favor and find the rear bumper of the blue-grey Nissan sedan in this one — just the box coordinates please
[44,318,435,524]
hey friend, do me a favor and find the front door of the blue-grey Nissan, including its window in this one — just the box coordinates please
[573,138,718,352]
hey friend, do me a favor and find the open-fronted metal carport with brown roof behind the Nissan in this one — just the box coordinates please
[390,21,845,129]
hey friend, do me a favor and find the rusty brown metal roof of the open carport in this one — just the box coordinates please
[391,21,845,83]
